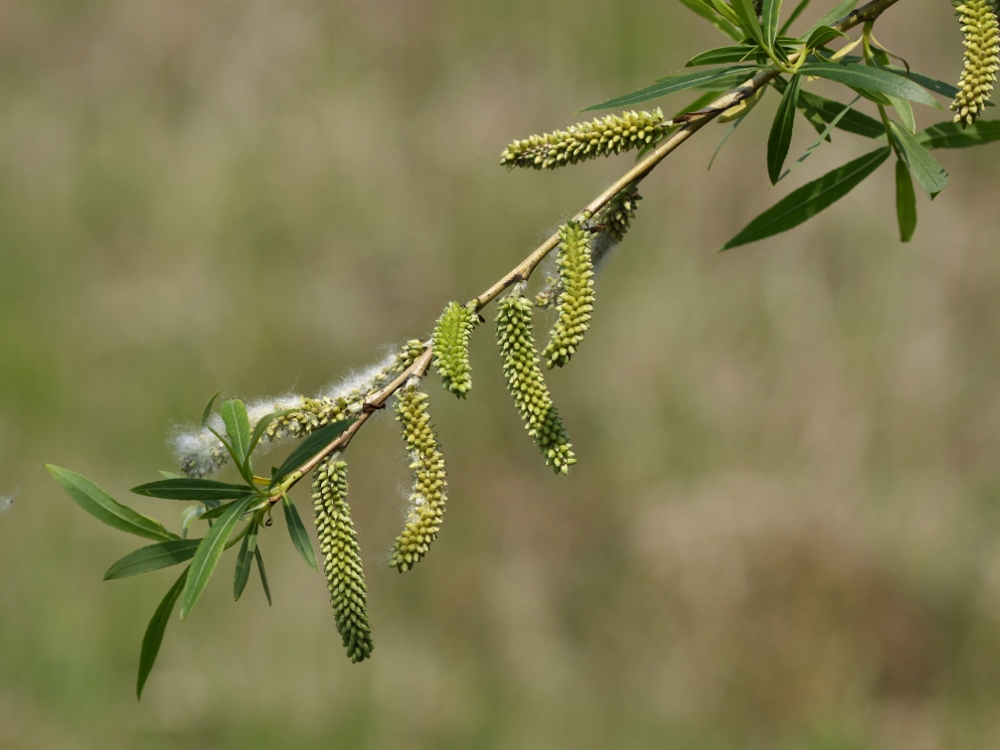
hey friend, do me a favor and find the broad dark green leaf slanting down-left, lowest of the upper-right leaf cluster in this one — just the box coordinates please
[720,147,892,250]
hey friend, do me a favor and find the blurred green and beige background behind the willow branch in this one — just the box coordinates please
[0,0,1000,750]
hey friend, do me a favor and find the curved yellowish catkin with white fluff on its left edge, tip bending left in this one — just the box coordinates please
[389,378,448,573]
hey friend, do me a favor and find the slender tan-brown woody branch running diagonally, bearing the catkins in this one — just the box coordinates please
[270,0,899,504]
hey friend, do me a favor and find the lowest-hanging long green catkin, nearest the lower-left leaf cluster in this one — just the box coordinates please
[312,455,374,663]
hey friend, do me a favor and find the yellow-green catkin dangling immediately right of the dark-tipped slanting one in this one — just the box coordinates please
[542,221,594,370]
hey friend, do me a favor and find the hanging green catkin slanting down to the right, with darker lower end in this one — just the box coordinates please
[497,287,576,474]
